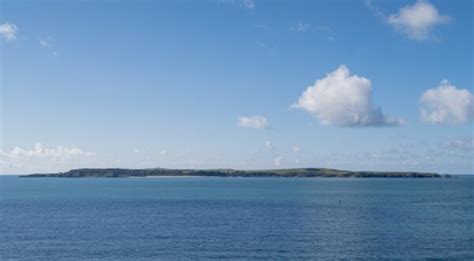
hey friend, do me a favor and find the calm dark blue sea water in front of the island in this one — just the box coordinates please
[0,177,474,260]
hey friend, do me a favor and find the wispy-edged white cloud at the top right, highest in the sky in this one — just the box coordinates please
[387,0,450,40]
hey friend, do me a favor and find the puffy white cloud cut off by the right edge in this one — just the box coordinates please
[420,80,474,124]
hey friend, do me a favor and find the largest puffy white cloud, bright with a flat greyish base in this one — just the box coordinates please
[292,65,401,127]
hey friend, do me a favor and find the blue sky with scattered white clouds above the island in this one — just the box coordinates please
[0,0,474,174]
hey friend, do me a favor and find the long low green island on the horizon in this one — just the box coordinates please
[20,168,451,178]
